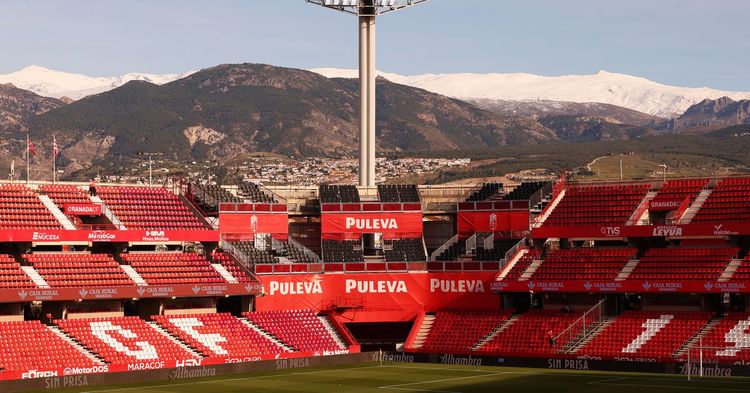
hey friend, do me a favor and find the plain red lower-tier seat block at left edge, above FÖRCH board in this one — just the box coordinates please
[0,321,96,370]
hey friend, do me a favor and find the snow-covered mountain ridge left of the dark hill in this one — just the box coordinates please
[0,65,193,100]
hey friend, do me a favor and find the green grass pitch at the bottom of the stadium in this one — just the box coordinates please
[32,363,750,393]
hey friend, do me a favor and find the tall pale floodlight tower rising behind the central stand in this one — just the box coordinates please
[305,0,427,187]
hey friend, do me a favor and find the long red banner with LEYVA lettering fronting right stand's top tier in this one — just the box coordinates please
[531,221,750,239]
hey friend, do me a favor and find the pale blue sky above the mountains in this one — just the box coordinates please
[0,0,750,91]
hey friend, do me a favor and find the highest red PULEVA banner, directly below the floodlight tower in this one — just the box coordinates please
[320,212,422,239]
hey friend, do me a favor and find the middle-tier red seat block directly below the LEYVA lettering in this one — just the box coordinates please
[628,247,739,280]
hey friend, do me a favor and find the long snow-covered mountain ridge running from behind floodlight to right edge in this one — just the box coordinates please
[311,68,750,117]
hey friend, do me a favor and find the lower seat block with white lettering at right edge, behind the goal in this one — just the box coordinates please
[704,313,750,363]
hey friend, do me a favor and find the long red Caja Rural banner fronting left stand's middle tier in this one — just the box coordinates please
[0,283,262,303]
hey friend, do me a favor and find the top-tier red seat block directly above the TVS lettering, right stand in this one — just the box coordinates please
[544,184,650,226]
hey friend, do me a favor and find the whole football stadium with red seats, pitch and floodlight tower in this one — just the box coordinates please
[0,0,750,393]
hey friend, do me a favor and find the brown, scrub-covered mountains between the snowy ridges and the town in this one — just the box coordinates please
[0,64,750,177]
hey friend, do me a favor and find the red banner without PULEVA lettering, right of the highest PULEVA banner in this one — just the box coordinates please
[458,210,529,239]
